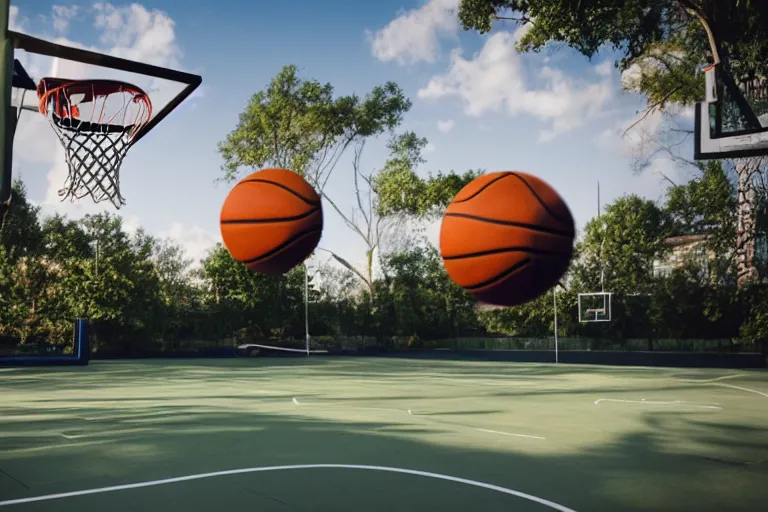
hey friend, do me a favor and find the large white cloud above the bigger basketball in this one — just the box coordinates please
[418,26,615,141]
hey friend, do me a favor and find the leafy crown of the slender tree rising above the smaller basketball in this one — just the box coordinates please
[219,66,411,188]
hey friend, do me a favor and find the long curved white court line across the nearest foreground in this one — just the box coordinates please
[0,464,576,512]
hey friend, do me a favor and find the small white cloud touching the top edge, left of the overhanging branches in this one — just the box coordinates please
[368,0,459,65]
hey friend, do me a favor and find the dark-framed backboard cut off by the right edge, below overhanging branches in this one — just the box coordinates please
[694,64,768,160]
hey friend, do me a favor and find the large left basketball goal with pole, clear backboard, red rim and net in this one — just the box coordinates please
[0,0,202,222]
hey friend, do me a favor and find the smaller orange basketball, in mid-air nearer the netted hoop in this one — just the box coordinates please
[221,169,323,275]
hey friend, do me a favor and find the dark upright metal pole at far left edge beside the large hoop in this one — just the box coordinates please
[0,0,16,227]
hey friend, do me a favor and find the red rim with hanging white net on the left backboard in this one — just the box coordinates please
[37,78,152,209]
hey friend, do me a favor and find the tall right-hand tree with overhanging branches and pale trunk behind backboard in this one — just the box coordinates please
[459,0,768,287]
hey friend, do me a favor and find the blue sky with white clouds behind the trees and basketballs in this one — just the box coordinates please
[10,0,692,276]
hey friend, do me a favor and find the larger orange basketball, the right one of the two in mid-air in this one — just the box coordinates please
[440,172,576,306]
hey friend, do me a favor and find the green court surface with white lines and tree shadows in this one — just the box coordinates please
[0,357,768,512]
